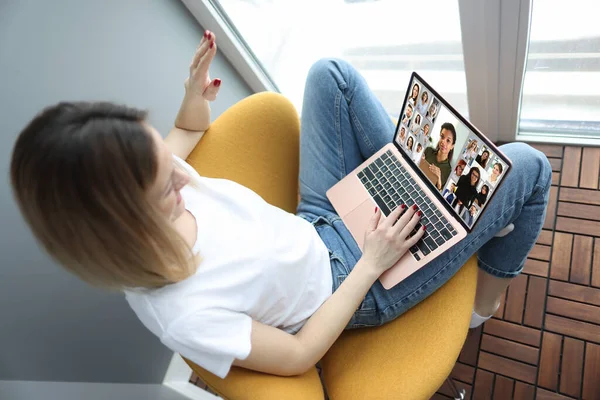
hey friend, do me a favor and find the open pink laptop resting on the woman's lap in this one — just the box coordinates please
[327,72,511,289]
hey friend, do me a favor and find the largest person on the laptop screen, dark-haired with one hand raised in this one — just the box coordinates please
[423,122,456,190]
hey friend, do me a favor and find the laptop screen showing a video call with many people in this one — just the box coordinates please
[394,73,510,229]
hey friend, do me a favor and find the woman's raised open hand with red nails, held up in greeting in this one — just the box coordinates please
[185,31,221,101]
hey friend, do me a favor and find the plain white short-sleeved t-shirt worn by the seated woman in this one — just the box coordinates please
[125,159,332,378]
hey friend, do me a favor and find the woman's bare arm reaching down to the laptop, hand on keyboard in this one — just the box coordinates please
[234,207,424,376]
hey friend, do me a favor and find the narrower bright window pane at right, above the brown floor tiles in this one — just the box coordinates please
[519,0,600,138]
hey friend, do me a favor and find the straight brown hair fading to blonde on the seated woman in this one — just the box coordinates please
[11,102,196,289]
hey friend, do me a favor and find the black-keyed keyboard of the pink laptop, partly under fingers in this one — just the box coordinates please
[358,150,457,260]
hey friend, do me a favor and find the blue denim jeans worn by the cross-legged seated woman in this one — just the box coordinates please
[297,60,552,329]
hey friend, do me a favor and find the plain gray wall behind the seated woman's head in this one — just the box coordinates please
[0,0,250,384]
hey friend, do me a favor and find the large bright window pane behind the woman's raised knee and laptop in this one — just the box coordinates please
[211,0,468,118]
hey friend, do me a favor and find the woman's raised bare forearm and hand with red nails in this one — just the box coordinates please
[165,31,221,160]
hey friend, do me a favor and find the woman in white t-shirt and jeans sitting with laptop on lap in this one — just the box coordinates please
[11,38,551,377]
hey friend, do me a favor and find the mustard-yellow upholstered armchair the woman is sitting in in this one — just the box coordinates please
[186,92,477,400]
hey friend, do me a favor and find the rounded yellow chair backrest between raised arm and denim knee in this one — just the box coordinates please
[187,92,300,212]
